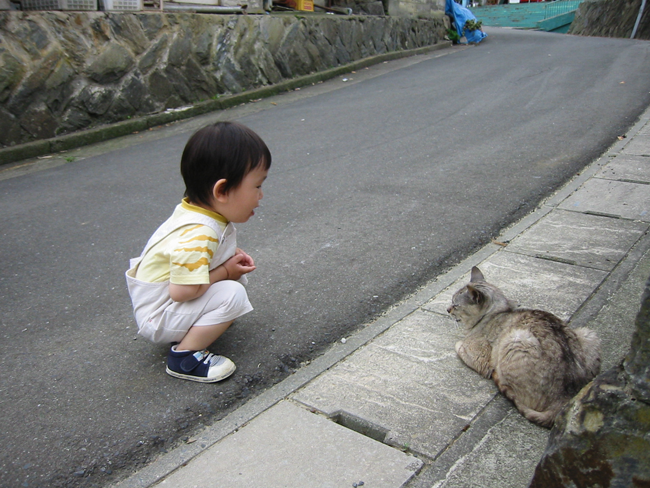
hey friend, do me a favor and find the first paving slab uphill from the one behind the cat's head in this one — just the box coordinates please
[508,210,650,271]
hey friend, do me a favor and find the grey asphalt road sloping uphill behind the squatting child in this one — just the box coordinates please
[0,29,650,487]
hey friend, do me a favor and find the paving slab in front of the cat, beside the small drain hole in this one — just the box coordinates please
[293,311,497,457]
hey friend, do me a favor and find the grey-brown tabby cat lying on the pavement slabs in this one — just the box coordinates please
[447,266,600,427]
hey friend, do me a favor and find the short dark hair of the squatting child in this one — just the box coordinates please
[181,122,271,205]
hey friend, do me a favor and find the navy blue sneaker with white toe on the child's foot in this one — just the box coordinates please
[167,346,236,383]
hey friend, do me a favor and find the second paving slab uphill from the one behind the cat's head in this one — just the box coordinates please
[560,178,650,222]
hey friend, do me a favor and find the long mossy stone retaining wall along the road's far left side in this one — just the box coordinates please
[0,11,448,147]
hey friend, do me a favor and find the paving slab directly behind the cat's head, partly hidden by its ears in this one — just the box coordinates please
[423,252,607,320]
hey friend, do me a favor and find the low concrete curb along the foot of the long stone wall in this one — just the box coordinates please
[0,42,451,166]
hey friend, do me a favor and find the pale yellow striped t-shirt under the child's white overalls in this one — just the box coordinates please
[135,199,228,285]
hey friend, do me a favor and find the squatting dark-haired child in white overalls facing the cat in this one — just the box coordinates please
[126,122,271,383]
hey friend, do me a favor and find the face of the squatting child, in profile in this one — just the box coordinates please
[215,166,269,224]
